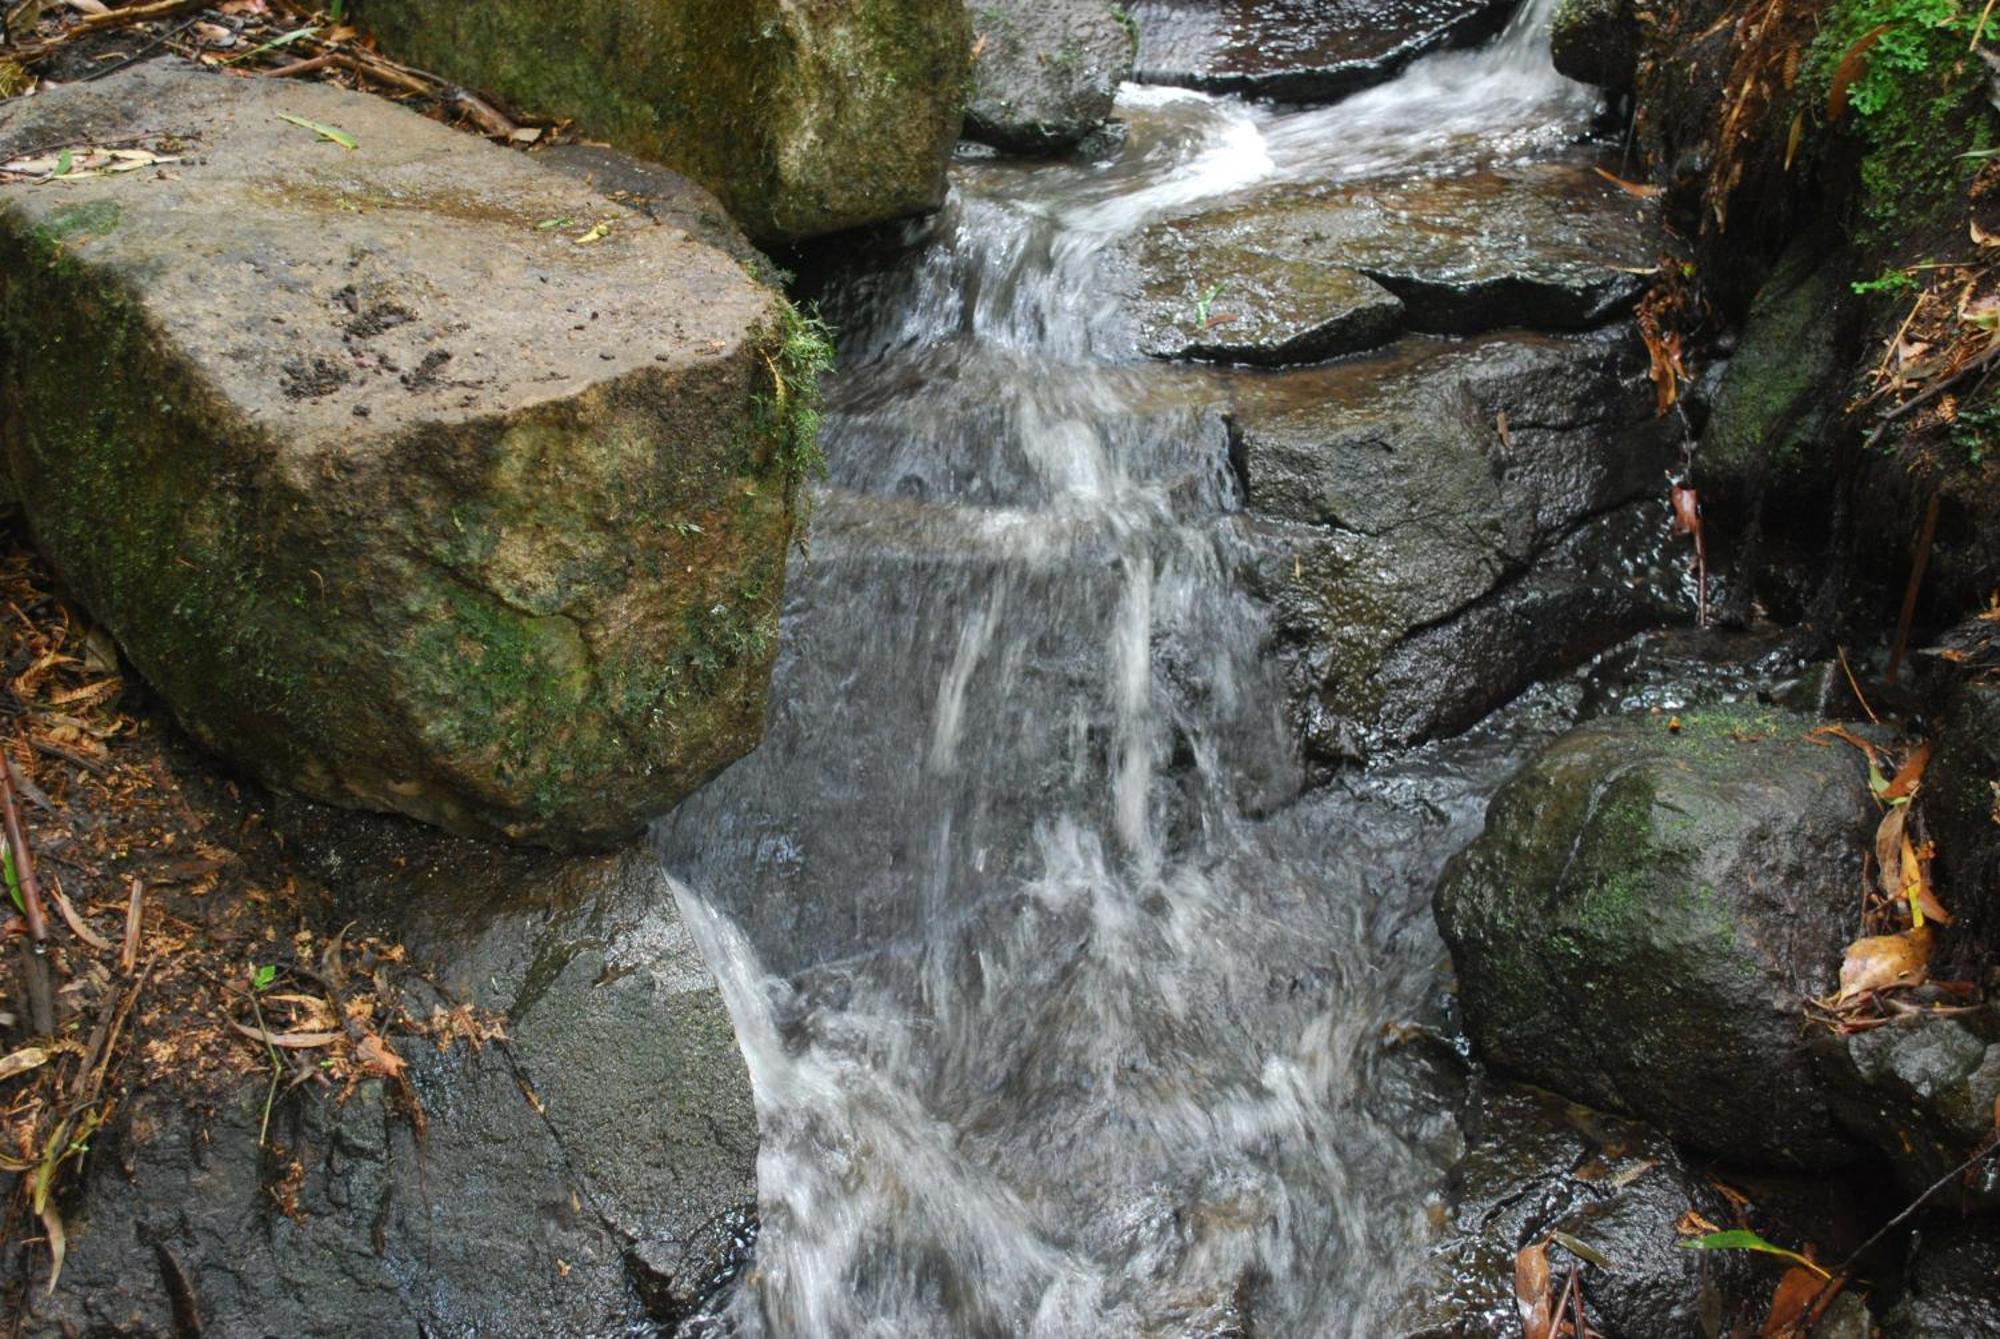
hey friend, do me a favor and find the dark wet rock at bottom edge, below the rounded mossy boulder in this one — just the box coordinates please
[1388,1081,1854,1339]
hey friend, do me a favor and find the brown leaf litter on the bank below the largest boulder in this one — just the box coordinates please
[0,530,506,1289]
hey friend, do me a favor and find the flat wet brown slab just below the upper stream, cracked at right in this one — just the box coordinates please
[1132,162,1658,364]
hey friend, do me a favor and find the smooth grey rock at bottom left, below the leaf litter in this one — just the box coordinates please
[24,835,756,1339]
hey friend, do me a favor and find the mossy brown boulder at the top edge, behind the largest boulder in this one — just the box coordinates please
[356,0,972,242]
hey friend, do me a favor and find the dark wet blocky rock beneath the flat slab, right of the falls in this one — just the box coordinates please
[1230,330,1682,759]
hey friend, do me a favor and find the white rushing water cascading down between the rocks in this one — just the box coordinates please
[660,2,1616,1337]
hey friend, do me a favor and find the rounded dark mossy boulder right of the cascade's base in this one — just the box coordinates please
[1436,707,1874,1167]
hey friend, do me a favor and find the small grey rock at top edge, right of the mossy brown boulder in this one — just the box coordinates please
[966,0,1134,154]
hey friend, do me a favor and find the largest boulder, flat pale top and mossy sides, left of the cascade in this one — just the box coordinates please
[0,62,824,845]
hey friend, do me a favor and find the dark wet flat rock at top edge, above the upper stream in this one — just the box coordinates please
[1132,0,1514,102]
